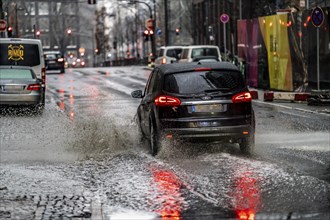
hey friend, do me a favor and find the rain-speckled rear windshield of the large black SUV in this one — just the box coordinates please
[164,71,245,94]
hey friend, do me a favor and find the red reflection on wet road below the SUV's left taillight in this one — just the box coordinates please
[151,168,184,220]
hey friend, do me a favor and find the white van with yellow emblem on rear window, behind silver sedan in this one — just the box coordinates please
[0,38,46,104]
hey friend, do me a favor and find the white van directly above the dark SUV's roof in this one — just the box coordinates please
[179,45,222,63]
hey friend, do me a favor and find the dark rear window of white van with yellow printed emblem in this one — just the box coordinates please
[0,43,40,66]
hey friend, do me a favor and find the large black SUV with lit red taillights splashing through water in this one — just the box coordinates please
[132,62,255,155]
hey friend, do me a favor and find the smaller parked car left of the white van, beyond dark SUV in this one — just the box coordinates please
[155,46,183,66]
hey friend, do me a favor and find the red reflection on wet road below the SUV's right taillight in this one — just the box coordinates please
[233,172,260,220]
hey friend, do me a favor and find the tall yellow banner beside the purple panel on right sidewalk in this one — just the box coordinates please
[259,14,293,91]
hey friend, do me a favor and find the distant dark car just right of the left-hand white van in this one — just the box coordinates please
[44,51,65,73]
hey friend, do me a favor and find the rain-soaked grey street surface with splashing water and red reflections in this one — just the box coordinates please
[0,67,330,220]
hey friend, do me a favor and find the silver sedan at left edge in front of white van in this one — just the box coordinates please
[0,66,44,109]
